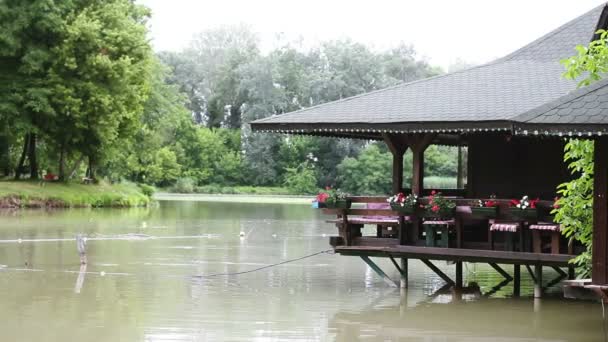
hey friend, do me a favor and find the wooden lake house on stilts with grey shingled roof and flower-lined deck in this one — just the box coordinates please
[251,6,608,297]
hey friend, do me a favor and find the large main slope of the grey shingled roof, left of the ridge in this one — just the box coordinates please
[252,6,604,136]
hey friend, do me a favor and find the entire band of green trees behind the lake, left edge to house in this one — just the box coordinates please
[0,0,457,193]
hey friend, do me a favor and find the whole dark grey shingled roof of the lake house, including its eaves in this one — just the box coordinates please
[251,5,608,139]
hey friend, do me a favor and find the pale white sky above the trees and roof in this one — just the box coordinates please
[139,0,605,68]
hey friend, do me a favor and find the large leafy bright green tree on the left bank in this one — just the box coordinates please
[0,0,151,178]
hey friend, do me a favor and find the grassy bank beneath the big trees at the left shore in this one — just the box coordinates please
[0,181,151,208]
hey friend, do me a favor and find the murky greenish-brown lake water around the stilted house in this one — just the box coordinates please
[0,201,605,342]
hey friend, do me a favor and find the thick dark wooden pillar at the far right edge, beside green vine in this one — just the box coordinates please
[591,137,608,285]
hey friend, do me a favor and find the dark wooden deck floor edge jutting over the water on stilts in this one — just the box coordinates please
[335,245,573,267]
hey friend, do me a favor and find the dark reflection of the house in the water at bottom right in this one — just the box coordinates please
[329,294,603,342]
